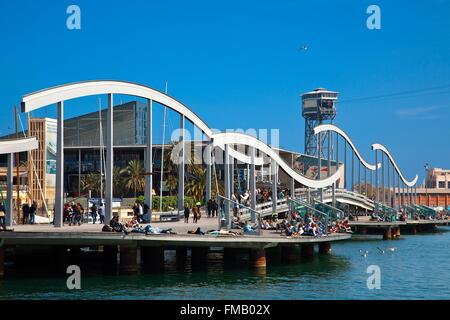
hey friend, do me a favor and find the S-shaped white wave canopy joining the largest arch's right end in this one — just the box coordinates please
[212,132,343,188]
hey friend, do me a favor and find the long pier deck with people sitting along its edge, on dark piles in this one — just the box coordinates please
[0,218,351,249]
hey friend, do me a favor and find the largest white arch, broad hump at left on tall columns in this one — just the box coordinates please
[22,80,213,137]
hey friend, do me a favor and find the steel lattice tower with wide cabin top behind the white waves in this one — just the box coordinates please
[302,88,339,158]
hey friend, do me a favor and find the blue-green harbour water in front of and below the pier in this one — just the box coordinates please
[0,227,450,300]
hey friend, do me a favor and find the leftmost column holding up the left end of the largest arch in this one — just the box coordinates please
[53,101,64,228]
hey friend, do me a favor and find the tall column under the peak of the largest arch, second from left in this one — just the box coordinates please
[105,94,114,225]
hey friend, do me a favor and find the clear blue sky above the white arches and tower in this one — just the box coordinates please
[0,0,450,180]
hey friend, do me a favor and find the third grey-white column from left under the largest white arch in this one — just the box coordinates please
[145,99,153,222]
